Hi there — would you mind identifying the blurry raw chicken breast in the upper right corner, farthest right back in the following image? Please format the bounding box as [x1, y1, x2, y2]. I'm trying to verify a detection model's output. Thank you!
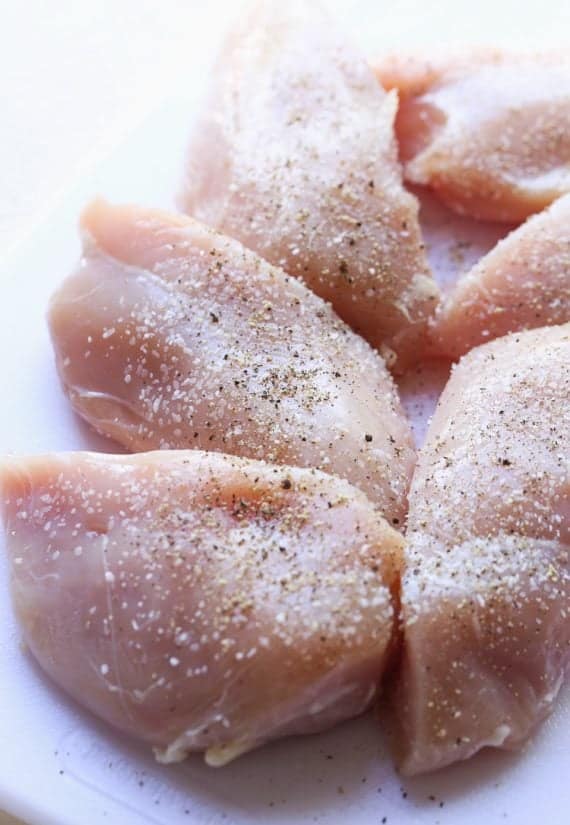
[376, 51, 570, 223]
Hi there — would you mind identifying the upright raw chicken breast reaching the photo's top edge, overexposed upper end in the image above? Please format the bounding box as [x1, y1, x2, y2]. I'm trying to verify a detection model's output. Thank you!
[183, 0, 438, 368]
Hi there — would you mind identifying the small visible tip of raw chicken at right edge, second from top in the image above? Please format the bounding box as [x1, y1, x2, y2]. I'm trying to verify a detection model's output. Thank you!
[432, 195, 570, 358]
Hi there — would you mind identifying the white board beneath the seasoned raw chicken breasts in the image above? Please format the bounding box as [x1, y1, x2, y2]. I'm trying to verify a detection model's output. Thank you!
[0, 2, 570, 825]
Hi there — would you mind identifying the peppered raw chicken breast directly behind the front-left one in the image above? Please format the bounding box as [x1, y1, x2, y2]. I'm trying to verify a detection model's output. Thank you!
[49, 201, 415, 524]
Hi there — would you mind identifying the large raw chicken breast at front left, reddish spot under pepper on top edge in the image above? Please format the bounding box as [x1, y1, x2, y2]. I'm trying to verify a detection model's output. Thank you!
[0, 450, 402, 765]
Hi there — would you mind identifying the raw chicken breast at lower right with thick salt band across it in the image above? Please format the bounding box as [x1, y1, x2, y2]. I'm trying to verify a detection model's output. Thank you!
[394, 324, 570, 774]
